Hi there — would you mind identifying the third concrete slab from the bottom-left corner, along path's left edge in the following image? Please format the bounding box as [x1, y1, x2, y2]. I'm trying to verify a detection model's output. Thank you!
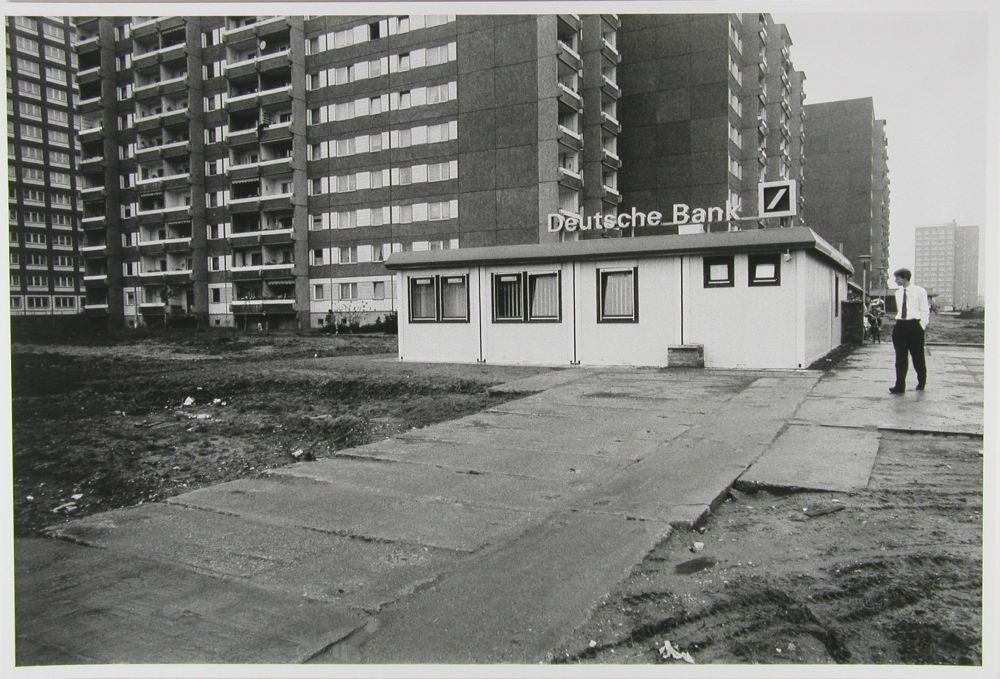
[169, 476, 530, 552]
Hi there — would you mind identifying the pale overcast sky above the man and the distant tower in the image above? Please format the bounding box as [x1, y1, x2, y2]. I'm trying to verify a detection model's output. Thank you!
[771, 3, 992, 293]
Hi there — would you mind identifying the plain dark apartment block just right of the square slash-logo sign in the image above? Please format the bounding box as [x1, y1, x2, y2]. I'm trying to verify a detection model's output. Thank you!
[804, 97, 890, 290]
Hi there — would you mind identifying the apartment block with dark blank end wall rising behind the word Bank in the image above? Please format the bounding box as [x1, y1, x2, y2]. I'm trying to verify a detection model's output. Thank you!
[619, 14, 802, 235]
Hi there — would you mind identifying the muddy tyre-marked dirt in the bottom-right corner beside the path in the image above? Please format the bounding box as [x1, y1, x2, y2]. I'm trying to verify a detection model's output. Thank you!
[556, 434, 982, 665]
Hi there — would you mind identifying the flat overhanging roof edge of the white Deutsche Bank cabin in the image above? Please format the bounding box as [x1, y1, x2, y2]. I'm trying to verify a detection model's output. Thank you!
[385, 226, 854, 274]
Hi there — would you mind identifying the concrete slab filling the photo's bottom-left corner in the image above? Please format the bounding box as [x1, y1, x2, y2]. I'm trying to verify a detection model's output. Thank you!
[15, 538, 364, 666]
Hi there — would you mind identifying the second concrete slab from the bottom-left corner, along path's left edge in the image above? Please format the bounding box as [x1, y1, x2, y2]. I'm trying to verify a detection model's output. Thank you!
[48, 503, 457, 610]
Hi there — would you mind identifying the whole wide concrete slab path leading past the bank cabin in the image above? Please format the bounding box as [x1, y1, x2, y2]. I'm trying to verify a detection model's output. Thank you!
[16, 346, 982, 665]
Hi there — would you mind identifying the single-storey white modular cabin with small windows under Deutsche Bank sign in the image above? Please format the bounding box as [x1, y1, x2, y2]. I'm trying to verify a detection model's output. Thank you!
[386, 227, 853, 369]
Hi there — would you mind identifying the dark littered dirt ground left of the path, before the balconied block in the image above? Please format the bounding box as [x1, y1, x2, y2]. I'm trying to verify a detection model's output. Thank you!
[11, 333, 541, 536]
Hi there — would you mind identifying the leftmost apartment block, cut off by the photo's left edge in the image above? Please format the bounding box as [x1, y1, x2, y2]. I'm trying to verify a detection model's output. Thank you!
[6, 16, 83, 315]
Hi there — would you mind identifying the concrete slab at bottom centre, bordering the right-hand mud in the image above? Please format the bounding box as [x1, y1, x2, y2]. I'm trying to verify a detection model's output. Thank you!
[348, 512, 670, 663]
